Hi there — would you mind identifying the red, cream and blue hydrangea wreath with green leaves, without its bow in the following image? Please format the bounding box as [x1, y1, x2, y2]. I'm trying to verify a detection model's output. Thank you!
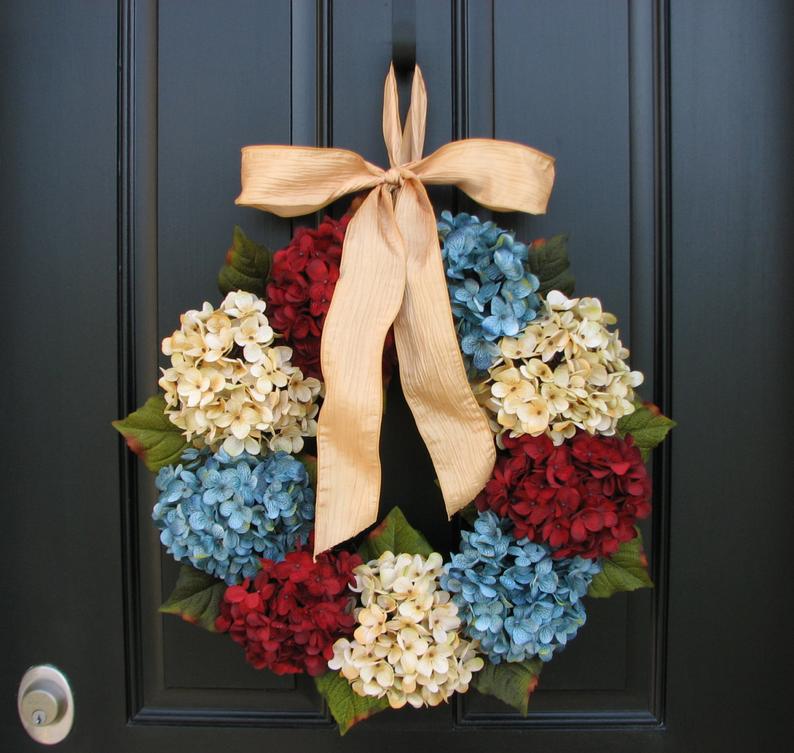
[114, 202, 674, 734]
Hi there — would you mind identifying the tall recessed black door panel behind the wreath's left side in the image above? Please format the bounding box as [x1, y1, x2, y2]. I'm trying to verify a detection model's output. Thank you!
[147, 0, 326, 723]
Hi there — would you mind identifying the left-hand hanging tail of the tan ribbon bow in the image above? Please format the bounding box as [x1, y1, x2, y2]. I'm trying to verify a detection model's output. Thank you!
[314, 186, 405, 556]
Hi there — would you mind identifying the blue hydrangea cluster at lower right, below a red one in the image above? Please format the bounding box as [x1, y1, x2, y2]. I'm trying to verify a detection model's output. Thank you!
[441, 510, 601, 664]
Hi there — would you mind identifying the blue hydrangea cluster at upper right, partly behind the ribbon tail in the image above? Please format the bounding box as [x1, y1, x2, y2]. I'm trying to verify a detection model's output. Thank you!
[438, 212, 541, 371]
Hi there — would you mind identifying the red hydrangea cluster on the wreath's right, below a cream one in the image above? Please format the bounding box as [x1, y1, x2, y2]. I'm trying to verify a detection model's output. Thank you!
[475, 431, 651, 559]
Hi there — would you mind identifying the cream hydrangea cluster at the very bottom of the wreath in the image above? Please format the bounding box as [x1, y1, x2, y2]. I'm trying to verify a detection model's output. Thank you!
[328, 552, 484, 708]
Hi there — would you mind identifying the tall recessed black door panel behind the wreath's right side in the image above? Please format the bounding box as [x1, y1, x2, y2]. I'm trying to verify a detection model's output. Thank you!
[459, 2, 666, 726]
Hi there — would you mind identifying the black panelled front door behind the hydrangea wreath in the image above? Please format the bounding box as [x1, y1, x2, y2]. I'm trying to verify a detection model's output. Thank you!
[0, 0, 794, 753]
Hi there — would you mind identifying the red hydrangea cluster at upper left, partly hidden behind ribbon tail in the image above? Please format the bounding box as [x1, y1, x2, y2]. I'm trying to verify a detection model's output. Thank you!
[265, 215, 396, 379]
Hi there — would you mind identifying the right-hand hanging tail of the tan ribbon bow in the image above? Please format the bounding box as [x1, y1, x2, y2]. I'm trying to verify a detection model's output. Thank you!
[394, 179, 496, 518]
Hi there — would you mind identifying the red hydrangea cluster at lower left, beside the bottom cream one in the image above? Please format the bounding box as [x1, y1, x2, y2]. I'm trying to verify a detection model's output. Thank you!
[215, 551, 361, 676]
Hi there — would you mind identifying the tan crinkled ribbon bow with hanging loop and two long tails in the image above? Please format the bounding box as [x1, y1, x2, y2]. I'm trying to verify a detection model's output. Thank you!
[236, 66, 554, 553]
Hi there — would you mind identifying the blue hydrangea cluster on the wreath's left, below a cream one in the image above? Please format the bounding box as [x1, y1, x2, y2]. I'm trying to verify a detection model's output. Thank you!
[152, 449, 314, 585]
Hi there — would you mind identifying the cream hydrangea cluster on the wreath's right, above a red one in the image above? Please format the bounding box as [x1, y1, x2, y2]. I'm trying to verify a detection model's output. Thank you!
[474, 290, 643, 444]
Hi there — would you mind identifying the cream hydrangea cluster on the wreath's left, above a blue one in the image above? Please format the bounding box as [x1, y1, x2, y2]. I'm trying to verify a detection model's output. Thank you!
[159, 291, 322, 457]
